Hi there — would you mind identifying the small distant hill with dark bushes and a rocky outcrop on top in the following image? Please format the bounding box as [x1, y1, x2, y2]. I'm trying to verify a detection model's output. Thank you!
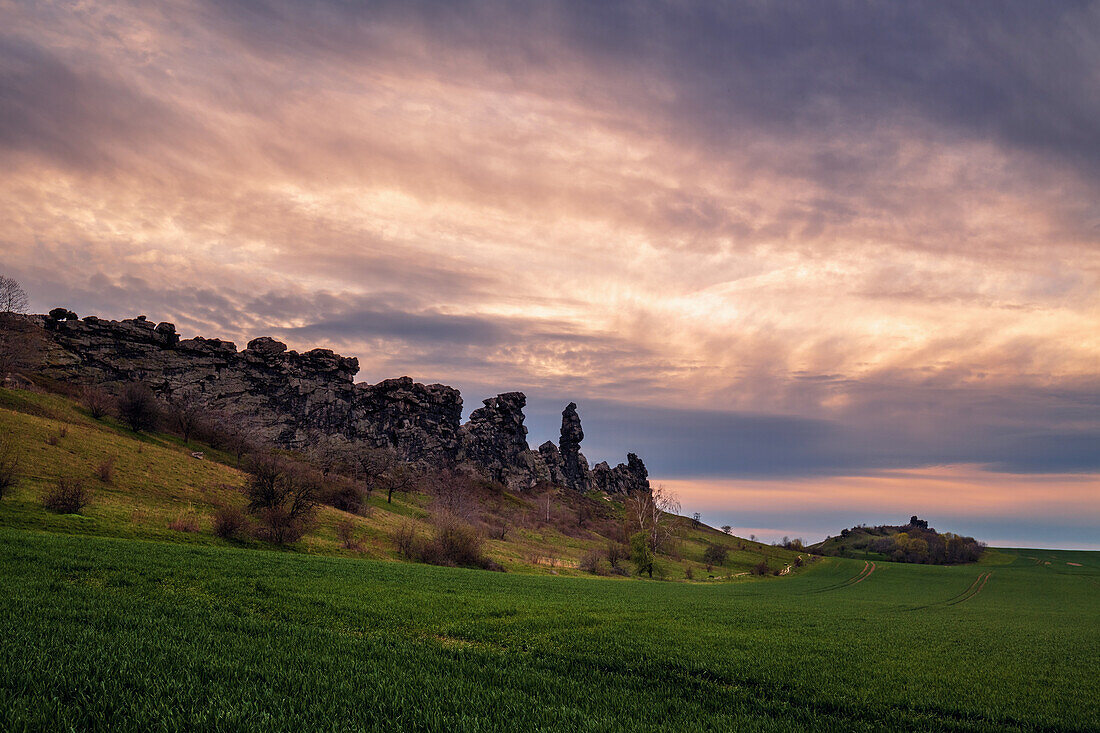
[809, 516, 986, 565]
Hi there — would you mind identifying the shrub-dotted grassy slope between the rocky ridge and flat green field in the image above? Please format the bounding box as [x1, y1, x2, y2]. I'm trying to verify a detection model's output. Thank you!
[0, 378, 809, 582]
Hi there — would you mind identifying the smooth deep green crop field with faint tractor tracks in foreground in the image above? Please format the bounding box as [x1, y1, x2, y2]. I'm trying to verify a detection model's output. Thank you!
[0, 528, 1100, 732]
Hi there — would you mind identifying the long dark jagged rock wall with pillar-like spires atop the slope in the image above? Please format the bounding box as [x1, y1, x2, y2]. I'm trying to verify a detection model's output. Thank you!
[30, 309, 649, 493]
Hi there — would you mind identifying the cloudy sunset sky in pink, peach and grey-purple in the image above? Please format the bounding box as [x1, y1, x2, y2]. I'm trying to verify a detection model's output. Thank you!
[0, 0, 1100, 549]
